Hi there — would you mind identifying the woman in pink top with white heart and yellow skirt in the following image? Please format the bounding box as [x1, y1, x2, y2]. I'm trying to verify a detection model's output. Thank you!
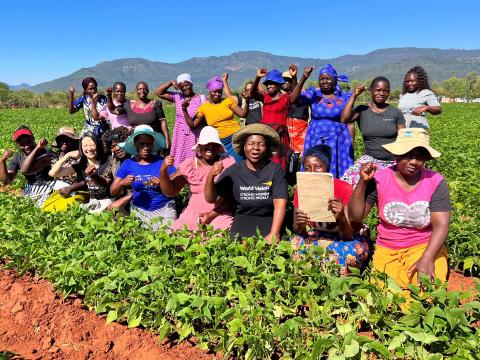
[348, 128, 451, 289]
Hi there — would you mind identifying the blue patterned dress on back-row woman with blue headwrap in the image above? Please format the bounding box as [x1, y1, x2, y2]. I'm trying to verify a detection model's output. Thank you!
[300, 87, 353, 178]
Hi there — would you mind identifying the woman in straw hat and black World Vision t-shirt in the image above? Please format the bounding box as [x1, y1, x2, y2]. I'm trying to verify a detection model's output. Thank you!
[205, 124, 288, 243]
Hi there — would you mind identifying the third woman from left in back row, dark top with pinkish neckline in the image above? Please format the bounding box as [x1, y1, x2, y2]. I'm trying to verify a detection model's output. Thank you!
[109, 81, 170, 149]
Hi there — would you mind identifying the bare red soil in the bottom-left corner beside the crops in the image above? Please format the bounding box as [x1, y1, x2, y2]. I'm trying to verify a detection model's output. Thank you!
[0, 269, 216, 360]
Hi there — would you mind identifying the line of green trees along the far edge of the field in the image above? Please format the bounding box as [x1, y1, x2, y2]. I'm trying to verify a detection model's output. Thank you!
[0, 72, 480, 109]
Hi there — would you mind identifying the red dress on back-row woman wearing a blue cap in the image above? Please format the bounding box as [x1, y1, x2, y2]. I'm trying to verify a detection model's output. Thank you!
[262, 93, 290, 171]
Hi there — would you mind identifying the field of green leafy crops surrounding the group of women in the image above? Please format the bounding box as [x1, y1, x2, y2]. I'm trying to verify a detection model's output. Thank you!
[0, 104, 480, 359]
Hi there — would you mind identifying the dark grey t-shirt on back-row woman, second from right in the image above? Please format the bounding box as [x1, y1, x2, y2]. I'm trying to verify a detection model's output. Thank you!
[353, 105, 405, 160]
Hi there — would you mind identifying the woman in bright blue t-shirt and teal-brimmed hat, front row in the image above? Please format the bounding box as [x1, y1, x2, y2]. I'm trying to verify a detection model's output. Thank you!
[110, 125, 177, 230]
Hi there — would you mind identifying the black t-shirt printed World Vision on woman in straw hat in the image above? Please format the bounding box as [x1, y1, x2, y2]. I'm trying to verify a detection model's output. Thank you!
[215, 161, 288, 237]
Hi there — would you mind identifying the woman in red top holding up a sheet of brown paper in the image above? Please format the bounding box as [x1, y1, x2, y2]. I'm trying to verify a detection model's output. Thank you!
[291, 144, 372, 274]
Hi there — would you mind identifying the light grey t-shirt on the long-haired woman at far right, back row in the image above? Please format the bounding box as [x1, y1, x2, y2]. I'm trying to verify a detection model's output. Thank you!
[398, 89, 440, 129]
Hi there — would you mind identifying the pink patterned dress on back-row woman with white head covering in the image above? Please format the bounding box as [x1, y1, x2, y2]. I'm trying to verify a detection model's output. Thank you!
[169, 92, 205, 167]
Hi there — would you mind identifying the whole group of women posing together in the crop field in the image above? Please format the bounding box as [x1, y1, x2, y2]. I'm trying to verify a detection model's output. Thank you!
[0, 65, 450, 287]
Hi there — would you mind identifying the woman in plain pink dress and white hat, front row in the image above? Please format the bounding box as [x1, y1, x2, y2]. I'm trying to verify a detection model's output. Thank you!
[160, 126, 235, 230]
